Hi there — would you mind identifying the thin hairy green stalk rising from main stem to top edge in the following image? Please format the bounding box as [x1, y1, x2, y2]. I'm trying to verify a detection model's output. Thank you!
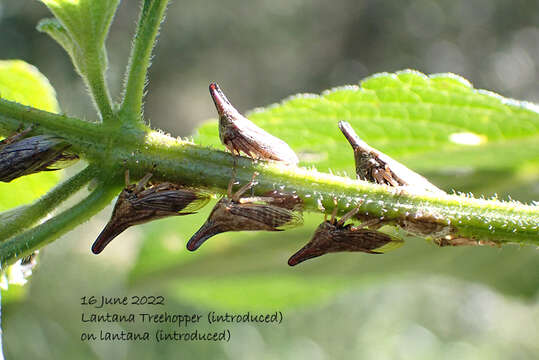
[120, 0, 168, 122]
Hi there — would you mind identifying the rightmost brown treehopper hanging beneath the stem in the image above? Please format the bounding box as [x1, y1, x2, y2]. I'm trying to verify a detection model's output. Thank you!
[288, 207, 400, 266]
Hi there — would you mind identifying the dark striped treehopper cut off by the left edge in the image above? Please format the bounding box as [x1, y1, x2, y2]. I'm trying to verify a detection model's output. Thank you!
[0, 134, 78, 182]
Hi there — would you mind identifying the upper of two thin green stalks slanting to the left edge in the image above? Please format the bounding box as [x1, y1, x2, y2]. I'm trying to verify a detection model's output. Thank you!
[0, 166, 96, 241]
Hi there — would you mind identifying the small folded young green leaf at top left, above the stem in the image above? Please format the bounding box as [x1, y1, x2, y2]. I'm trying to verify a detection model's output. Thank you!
[37, 0, 119, 83]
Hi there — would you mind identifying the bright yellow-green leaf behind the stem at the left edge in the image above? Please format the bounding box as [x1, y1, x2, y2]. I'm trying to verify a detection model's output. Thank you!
[0, 60, 60, 211]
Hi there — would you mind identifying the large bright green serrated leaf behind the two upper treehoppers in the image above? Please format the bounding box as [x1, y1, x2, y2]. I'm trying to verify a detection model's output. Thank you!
[196, 70, 539, 174]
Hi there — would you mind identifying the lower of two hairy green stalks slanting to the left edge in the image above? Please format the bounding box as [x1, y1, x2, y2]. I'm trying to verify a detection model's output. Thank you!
[0, 183, 119, 268]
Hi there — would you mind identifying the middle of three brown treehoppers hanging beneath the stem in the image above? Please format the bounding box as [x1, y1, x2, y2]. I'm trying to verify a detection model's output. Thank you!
[187, 173, 303, 251]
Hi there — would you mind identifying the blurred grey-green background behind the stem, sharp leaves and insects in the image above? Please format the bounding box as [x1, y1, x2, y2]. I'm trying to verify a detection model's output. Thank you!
[0, 0, 539, 359]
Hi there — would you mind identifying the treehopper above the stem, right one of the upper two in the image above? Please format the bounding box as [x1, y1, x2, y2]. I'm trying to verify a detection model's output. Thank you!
[339, 121, 443, 192]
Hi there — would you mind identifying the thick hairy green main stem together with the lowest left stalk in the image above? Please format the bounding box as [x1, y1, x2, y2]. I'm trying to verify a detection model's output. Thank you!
[0, 101, 539, 261]
